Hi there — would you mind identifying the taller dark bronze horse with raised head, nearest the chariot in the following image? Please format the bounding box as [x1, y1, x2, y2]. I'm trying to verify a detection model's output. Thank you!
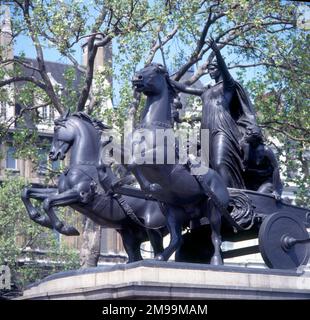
[108, 63, 229, 265]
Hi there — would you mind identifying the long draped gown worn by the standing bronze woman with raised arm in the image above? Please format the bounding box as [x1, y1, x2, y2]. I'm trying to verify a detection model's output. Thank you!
[201, 78, 252, 189]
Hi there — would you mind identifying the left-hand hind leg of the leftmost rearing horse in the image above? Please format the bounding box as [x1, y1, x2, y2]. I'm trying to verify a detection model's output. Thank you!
[117, 227, 143, 263]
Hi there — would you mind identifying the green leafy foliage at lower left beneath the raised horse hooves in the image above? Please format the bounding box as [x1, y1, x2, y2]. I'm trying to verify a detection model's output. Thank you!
[0, 177, 79, 289]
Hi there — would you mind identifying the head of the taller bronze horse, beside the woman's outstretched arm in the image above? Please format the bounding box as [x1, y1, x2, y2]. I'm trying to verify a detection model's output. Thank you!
[132, 63, 169, 96]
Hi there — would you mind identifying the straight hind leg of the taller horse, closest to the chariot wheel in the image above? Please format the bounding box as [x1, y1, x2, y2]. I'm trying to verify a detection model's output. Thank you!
[207, 204, 223, 265]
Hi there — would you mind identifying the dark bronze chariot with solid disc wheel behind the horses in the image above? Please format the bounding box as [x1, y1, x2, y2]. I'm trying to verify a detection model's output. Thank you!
[176, 189, 310, 269]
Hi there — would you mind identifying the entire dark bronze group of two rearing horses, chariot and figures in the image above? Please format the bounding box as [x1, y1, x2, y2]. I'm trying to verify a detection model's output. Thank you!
[22, 40, 310, 269]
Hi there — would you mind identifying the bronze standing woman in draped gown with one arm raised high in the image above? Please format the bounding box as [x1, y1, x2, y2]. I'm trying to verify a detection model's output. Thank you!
[172, 39, 256, 189]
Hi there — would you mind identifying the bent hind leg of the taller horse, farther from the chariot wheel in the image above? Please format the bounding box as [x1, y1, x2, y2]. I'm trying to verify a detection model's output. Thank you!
[155, 206, 184, 261]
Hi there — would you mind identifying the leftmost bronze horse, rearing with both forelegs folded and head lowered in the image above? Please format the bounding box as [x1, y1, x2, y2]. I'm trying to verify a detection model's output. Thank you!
[22, 112, 166, 263]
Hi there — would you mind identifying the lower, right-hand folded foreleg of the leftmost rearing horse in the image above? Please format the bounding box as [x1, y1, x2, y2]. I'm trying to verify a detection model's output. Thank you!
[43, 190, 80, 236]
